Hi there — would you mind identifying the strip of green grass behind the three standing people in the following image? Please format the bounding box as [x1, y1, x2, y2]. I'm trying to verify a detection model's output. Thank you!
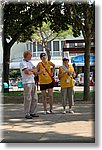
[3, 91, 95, 104]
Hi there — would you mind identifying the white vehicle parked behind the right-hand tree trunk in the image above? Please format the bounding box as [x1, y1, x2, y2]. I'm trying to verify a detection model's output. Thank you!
[75, 72, 94, 86]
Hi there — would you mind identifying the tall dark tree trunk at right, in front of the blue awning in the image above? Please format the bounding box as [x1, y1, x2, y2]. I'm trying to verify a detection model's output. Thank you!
[83, 3, 91, 101]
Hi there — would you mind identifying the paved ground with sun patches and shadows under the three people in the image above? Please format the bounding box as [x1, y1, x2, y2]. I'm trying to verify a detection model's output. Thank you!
[0, 103, 95, 143]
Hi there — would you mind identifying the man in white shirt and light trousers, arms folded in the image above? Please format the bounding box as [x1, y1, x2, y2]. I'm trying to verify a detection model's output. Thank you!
[20, 51, 39, 119]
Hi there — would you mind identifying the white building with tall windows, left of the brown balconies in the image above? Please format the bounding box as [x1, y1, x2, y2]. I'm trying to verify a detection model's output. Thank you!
[10, 37, 82, 69]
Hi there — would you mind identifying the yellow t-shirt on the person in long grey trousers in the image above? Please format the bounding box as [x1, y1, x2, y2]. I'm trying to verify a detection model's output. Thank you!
[59, 64, 74, 88]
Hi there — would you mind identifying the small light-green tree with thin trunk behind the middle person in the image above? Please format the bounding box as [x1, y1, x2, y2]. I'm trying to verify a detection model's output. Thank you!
[31, 22, 72, 60]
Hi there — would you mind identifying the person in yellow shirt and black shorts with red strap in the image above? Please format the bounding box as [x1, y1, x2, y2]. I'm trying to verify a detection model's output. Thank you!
[37, 53, 55, 114]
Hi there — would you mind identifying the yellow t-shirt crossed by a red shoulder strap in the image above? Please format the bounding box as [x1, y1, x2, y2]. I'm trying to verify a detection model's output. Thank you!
[39, 61, 52, 84]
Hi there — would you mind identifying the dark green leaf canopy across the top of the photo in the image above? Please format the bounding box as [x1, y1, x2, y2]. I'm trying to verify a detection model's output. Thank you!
[3, 1, 95, 41]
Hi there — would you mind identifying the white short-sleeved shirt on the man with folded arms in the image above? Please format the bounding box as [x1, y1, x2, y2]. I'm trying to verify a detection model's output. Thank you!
[20, 59, 35, 84]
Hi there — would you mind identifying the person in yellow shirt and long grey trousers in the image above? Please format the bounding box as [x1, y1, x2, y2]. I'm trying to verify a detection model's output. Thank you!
[58, 57, 75, 114]
